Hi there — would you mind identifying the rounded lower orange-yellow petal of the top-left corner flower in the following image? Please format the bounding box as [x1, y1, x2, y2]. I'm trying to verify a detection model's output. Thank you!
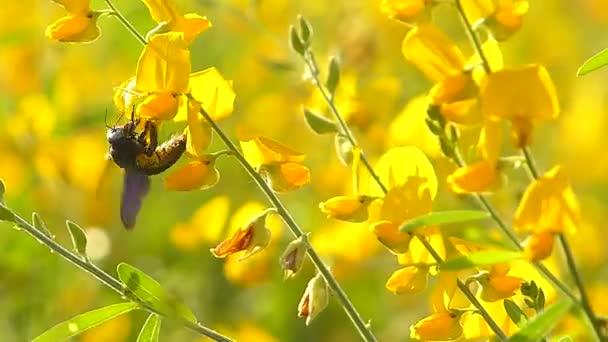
[45, 12, 100, 43]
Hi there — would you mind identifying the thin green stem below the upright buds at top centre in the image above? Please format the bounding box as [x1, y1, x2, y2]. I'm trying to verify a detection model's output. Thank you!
[303, 49, 388, 194]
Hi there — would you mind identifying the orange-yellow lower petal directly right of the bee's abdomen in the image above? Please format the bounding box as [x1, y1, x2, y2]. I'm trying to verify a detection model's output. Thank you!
[164, 156, 220, 191]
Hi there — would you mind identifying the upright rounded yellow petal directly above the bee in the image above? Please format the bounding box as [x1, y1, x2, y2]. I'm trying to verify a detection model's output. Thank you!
[135, 32, 191, 94]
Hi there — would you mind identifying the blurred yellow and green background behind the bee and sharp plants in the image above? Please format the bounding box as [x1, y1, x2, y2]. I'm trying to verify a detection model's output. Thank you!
[0, 0, 608, 341]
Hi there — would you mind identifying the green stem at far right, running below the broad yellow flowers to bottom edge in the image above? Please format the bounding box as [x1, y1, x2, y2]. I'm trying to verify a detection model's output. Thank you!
[522, 146, 606, 341]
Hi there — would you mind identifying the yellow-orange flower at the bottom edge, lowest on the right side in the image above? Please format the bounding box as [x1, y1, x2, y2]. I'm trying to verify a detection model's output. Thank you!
[410, 309, 463, 341]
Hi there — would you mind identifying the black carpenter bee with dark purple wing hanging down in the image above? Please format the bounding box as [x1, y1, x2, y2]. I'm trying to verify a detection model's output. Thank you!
[107, 115, 186, 229]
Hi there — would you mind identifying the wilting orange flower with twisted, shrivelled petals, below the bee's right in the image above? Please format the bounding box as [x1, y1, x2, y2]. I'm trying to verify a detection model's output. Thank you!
[211, 209, 275, 260]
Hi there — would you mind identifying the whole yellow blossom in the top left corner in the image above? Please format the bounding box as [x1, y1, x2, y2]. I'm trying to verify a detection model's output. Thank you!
[44, 0, 101, 43]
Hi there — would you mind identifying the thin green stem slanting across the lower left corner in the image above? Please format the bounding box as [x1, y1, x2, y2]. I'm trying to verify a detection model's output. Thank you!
[6, 208, 232, 342]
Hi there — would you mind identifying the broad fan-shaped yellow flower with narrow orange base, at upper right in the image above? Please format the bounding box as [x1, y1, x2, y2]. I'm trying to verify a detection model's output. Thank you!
[481, 65, 559, 147]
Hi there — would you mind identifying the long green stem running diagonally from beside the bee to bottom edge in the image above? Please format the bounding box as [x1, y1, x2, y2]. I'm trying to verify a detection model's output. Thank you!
[200, 107, 376, 341]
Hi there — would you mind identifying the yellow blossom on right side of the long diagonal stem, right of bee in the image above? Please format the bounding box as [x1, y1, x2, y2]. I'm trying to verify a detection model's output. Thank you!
[241, 137, 310, 192]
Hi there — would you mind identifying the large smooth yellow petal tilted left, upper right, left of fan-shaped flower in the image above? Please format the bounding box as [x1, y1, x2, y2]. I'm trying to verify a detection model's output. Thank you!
[401, 24, 466, 83]
